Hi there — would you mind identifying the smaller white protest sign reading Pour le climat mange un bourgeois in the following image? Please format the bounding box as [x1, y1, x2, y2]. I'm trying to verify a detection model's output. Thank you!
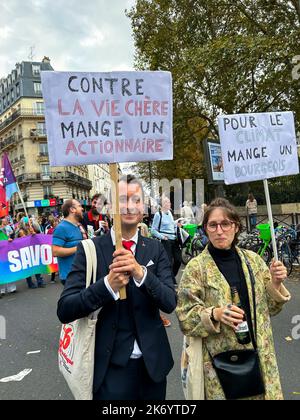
[218, 112, 299, 185]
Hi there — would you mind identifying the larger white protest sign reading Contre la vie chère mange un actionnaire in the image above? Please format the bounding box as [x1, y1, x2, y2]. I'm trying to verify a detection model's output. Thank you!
[41, 71, 173, 166]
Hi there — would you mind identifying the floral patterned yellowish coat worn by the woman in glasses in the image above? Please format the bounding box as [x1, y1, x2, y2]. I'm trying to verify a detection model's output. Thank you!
[176, 248, 291, 400]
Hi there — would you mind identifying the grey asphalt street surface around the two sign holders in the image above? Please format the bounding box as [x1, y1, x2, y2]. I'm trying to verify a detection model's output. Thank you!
[0, 270, 300, 400]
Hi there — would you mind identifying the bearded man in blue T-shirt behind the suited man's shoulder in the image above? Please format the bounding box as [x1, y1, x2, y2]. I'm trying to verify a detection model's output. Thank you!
[52, 199, 86, 285]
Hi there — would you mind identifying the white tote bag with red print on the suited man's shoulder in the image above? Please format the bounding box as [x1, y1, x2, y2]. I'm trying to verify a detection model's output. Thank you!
[58, 239, 100, 400]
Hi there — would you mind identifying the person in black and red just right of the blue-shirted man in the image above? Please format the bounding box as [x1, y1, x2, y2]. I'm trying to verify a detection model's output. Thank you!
[82, 194, 110, 236]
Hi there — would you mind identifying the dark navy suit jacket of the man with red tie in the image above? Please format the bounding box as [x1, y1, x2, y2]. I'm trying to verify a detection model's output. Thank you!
[57, 234, 176, 392]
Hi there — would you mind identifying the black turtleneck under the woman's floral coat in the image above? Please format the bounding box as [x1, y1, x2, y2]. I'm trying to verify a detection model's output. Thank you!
[208, 243, 252, 340]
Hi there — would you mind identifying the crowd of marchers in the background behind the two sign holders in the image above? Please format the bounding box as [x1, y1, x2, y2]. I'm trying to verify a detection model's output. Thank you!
[0, 193, 206, 298]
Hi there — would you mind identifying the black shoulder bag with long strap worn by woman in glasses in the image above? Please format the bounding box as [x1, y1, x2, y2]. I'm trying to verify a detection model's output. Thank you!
[210, 254, 265, 400]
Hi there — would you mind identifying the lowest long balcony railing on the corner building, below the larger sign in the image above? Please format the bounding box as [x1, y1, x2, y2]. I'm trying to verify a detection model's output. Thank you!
[17, 171, 92, 189]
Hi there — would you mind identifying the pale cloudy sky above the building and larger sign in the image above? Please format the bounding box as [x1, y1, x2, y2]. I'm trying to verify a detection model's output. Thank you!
[0, 0, 135, 78]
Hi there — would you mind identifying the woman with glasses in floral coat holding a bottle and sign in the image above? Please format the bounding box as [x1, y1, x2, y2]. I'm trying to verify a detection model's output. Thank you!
[177, 199, 291, 400]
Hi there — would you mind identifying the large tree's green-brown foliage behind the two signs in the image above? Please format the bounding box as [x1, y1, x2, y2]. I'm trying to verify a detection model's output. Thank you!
[127, 0, 300, 190]
